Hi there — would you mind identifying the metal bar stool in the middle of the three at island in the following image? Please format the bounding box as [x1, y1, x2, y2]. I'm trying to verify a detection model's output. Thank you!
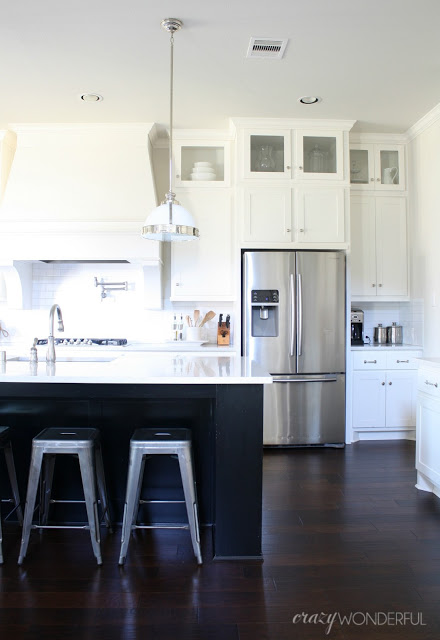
[18, 427, 112, 564]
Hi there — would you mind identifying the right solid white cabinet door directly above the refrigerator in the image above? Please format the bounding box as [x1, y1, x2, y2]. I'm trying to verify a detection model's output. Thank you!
[296, 187, 345, 243]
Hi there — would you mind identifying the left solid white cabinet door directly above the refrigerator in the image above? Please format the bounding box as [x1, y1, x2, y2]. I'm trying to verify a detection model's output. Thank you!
[243, 187, 292, 243]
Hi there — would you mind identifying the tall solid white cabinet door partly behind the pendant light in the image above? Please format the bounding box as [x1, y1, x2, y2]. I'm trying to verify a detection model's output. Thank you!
[171, 189, 234, 301]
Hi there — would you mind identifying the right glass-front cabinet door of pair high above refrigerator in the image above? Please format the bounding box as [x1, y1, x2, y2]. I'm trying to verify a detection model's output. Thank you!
[295, 131, 344, 180]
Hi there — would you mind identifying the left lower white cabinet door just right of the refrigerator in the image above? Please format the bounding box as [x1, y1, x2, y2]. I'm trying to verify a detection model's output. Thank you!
[353, 371, 385, 429]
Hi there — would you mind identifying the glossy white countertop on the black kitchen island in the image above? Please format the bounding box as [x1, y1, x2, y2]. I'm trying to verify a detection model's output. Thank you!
[0, 350, 272, 384]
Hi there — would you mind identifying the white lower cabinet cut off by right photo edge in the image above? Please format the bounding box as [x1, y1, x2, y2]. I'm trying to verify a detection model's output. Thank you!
[416, 363, 440, 496]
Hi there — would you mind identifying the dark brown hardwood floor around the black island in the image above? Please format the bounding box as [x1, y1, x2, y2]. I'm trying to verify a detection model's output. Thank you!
[0, 442, 440, 640]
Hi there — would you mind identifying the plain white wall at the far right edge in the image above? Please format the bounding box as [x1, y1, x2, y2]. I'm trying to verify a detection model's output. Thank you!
[408, 107, 440, 357]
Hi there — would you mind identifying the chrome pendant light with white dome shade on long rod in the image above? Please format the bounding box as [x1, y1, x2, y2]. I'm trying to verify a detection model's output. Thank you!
[142, 18, 199, 242]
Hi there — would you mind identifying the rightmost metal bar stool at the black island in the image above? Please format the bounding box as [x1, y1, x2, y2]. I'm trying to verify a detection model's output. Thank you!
[119, 429, 202, 565]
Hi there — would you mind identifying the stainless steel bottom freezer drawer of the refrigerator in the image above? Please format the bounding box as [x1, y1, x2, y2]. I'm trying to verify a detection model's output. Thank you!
[263, 374, 345, 445]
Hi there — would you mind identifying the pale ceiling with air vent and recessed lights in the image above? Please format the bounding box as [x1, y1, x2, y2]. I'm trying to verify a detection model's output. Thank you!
[0, 0, 440, 132]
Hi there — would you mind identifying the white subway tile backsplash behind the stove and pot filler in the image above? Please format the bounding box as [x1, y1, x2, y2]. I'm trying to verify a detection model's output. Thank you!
[0, 262, 234, 343]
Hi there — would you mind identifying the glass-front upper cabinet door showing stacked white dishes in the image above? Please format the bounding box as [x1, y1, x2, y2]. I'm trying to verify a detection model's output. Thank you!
[173, 140, 230, 187]
